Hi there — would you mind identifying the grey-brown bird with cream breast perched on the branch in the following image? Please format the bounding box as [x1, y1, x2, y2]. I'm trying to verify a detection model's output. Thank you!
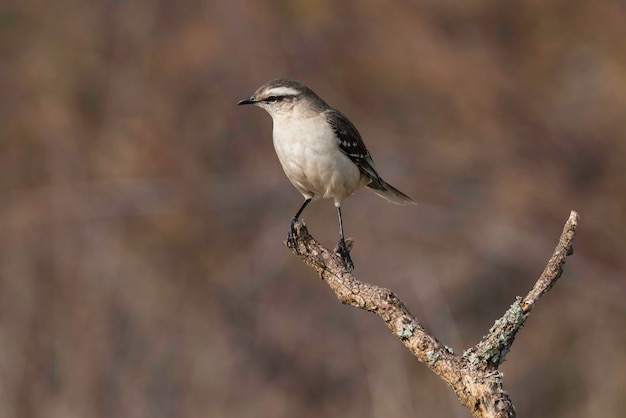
[237, 78, 416, 271]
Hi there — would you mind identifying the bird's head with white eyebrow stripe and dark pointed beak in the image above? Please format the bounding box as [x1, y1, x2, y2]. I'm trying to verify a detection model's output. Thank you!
[237, 78, 328, 117]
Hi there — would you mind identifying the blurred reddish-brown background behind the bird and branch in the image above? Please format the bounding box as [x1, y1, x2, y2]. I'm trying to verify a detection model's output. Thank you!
[0, 0, 626, 418]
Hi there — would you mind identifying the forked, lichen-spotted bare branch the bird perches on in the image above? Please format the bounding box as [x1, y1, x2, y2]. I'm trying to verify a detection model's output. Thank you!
[285, 211, 579, 418]
